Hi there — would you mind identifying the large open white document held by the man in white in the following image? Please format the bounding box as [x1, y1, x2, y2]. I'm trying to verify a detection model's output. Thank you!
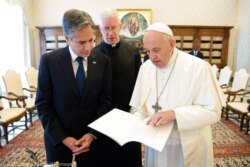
[88, 109, 173, 152]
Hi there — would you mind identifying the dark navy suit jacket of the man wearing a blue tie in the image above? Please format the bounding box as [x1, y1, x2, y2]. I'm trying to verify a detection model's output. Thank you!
[36, 47, 112, 166]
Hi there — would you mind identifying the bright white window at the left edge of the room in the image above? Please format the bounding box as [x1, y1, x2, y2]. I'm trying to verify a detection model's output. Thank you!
[0, 0, 29, 92]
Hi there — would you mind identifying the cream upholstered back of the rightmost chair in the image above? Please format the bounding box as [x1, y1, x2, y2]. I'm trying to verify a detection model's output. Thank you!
[231, 69, 249, 91]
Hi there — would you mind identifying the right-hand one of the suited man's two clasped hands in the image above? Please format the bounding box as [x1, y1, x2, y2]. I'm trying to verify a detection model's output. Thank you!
[72, 133, 95, 155]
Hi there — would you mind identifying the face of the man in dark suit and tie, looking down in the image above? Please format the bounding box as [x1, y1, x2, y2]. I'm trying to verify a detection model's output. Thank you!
[66, 26, 95, 57]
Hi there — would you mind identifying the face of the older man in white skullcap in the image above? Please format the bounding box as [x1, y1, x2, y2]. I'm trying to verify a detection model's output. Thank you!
[143, 31, 175, 68]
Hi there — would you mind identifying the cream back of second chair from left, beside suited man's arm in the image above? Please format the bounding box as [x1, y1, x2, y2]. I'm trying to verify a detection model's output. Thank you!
[25, 67, 38, 88]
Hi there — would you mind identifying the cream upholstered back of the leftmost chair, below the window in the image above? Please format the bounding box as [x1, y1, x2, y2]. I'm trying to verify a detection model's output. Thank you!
[3, 70, 24, 97]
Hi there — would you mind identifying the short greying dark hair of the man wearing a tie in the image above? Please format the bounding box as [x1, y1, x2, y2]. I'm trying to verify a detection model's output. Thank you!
[62, 9, 95, 39]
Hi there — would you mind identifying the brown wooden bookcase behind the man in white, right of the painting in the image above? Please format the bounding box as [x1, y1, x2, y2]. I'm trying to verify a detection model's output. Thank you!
[170, 25, 233, 68]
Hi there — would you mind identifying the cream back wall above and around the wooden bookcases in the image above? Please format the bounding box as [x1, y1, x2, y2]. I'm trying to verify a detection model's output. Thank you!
[29, 0, 250, 72]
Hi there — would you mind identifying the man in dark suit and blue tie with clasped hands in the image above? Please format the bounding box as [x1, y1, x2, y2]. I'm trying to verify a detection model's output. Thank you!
[36, 9, 112, 167]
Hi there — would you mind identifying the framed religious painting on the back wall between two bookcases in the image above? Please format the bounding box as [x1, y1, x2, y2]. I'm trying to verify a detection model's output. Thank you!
[117, 9, 151, 51]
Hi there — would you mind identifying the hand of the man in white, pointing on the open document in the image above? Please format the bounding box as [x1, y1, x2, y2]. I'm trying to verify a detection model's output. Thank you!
[147, 110, 175, 127]
